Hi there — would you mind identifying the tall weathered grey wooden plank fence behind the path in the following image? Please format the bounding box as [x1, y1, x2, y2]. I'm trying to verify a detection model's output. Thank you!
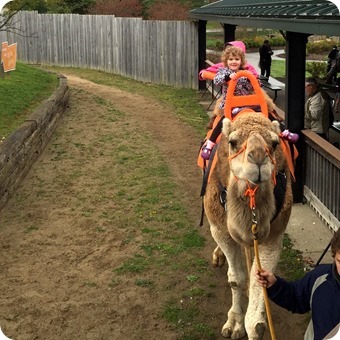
[0, 11, 198, 89]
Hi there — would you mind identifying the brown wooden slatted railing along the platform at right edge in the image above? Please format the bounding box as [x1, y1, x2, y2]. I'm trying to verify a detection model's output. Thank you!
[302, 130, 340, 230]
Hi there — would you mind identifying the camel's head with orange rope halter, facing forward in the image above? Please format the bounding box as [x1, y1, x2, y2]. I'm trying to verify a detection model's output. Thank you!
[222, 112, 280, 185]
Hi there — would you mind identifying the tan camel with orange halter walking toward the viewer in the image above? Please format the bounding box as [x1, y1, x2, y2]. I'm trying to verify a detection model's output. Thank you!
[203, 112, 293, 340]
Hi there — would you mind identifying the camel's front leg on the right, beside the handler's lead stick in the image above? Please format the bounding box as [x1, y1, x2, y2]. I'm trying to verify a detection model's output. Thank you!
[245, 241, 281, 340]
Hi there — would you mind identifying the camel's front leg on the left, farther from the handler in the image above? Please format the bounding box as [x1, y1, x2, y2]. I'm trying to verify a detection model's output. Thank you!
[211, 226, 247, 339]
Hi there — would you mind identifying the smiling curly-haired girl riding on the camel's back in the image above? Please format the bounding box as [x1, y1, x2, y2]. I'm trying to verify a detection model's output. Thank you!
[201, 46, 260, 160]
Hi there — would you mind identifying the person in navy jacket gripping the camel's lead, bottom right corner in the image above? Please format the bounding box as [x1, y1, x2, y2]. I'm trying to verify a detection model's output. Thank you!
[255, 228, 340, 340]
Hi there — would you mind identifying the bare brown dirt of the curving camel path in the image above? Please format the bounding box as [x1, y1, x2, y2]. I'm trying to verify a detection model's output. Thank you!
[0, 74, 306, 340]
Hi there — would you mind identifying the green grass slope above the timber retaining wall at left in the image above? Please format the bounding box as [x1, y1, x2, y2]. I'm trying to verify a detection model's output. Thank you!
[0, 62, 58, 137]
